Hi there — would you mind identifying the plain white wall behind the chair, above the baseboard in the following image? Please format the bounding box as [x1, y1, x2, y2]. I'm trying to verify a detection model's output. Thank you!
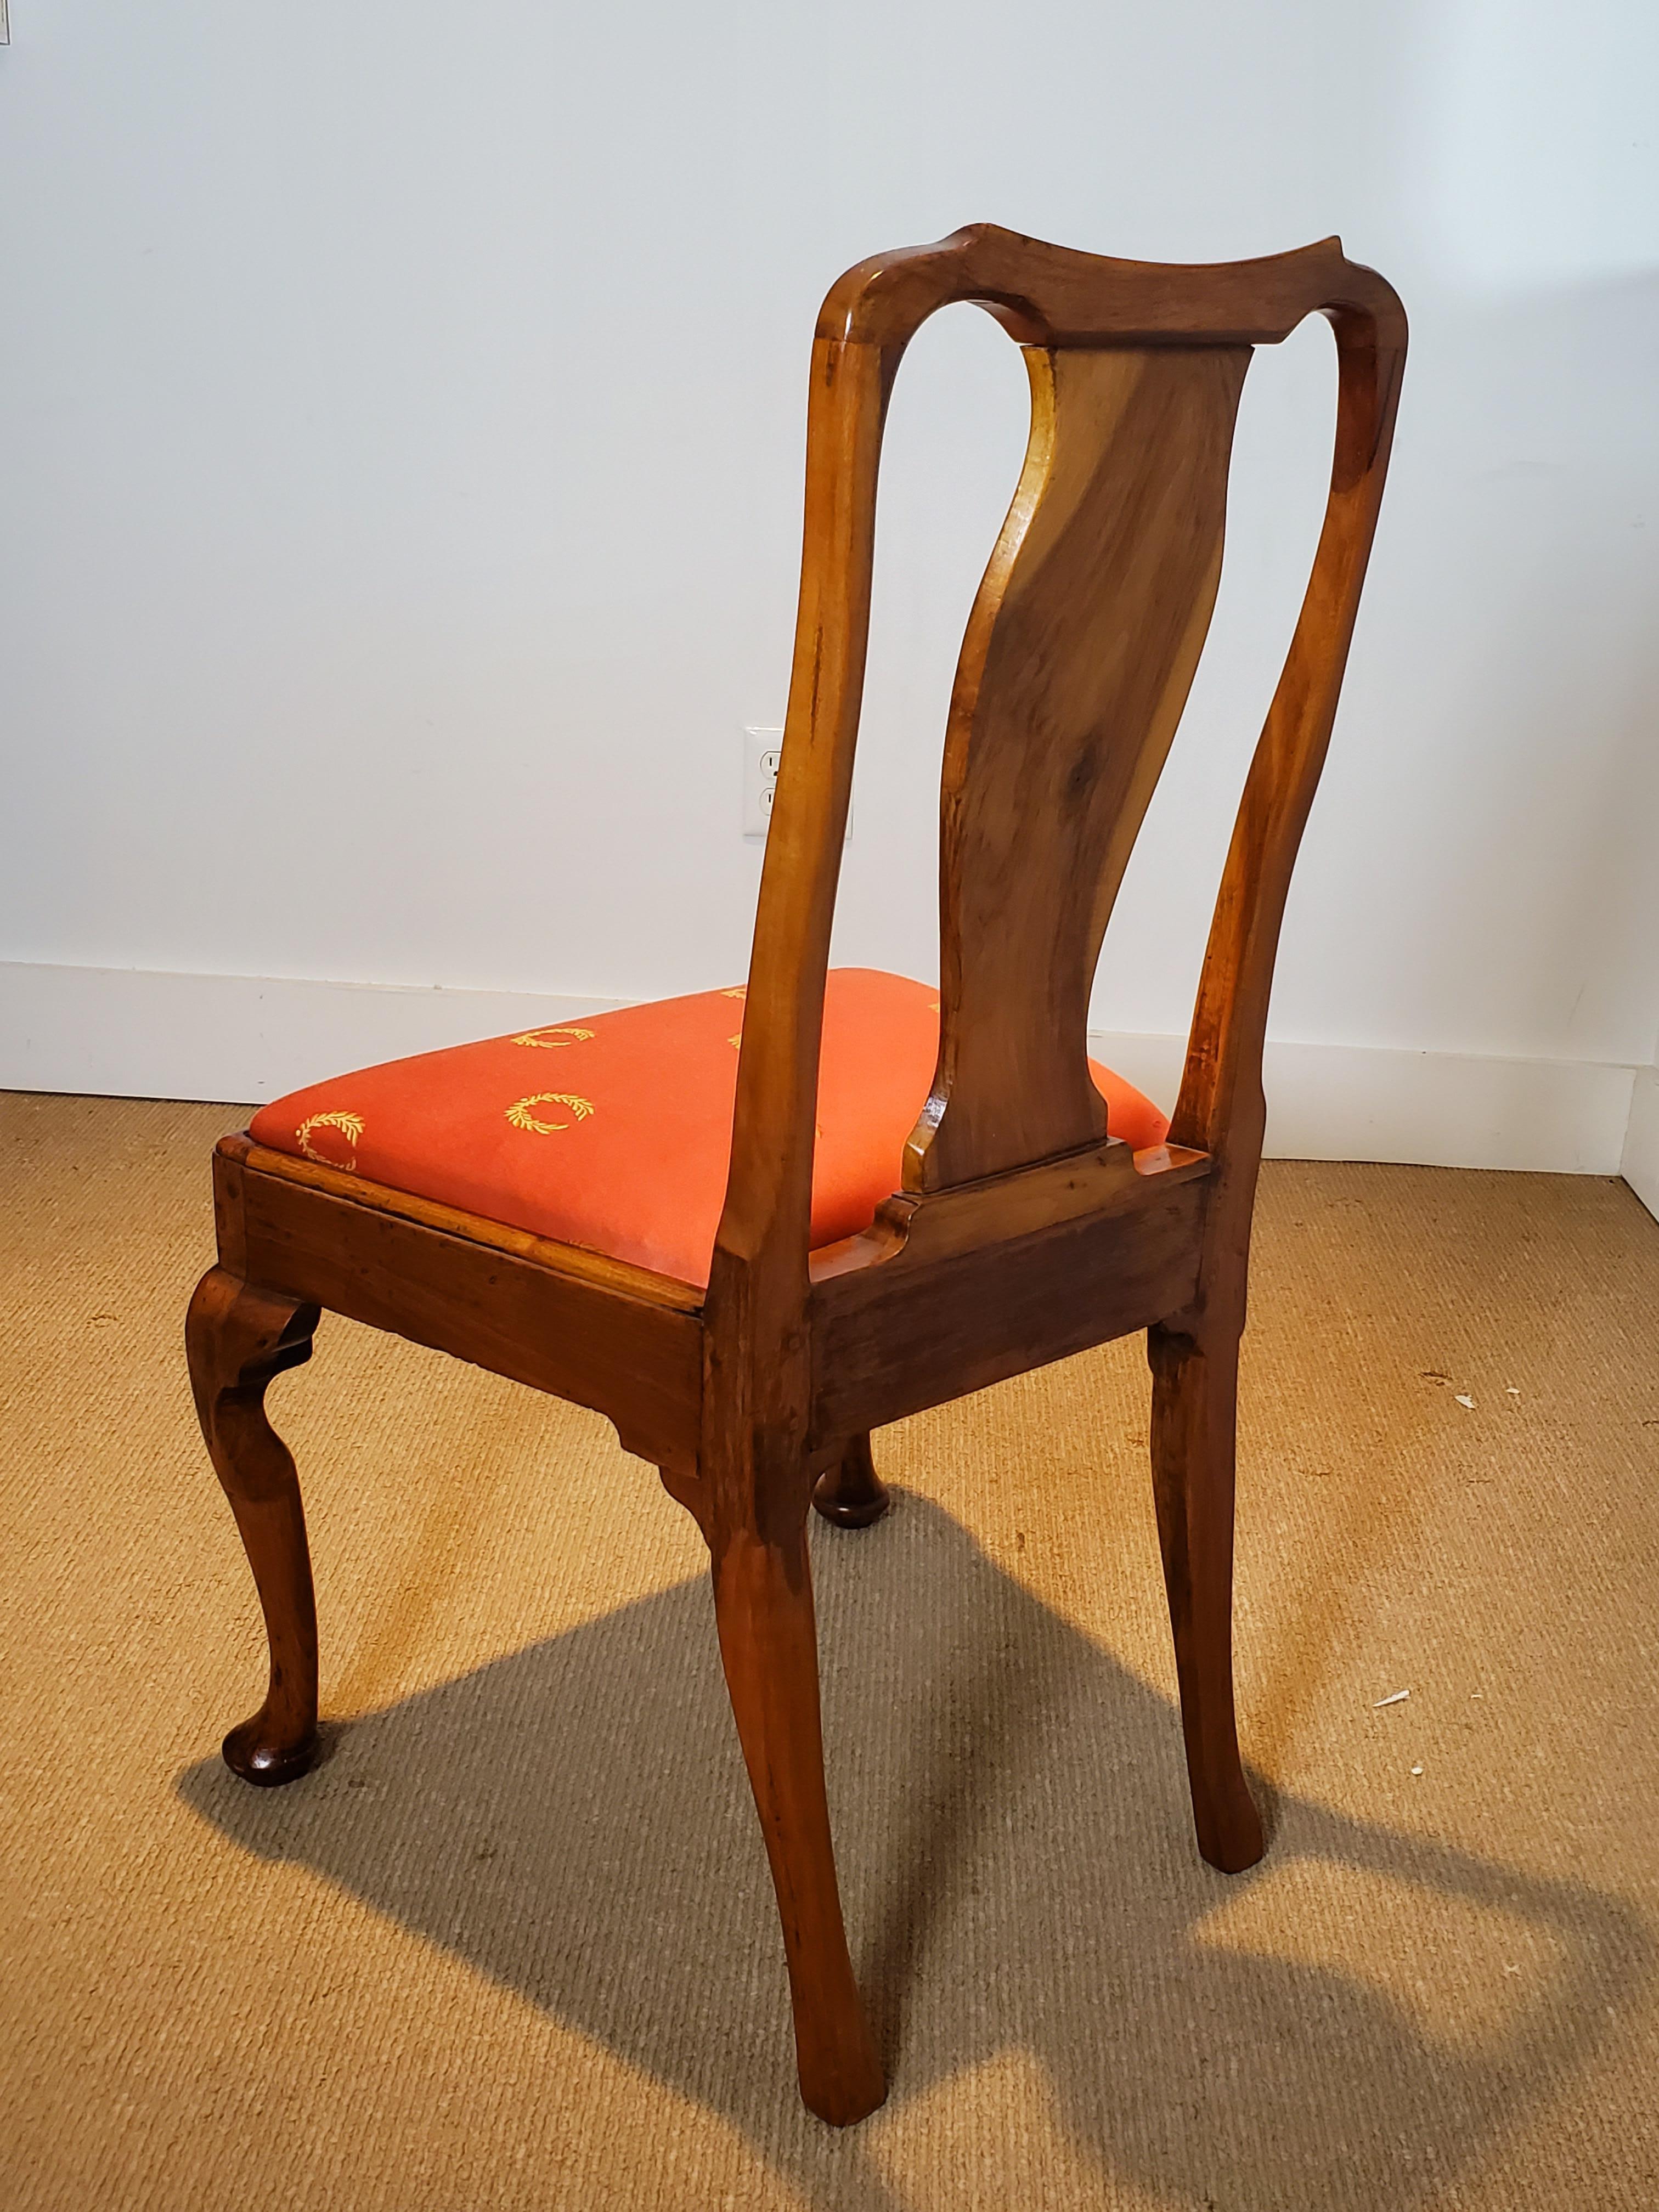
[0, 0, 1659, 1168]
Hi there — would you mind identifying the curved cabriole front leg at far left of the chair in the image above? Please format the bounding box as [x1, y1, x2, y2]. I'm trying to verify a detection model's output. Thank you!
[184, 1267, 319, 1785]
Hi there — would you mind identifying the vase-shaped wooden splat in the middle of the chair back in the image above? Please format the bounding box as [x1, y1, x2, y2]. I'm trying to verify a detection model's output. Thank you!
[924, 345, 1250, 1190]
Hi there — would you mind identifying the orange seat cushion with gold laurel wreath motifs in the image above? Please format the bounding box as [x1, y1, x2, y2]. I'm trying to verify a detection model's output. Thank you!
[252, 969, 1168, 1285]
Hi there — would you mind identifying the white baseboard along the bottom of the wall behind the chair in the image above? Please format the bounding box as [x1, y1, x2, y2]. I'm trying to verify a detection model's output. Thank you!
[0, 962, 1659, 1186]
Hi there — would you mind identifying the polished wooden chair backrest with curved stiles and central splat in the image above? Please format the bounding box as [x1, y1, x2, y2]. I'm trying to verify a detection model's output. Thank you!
[708, 225, 1404, 1451]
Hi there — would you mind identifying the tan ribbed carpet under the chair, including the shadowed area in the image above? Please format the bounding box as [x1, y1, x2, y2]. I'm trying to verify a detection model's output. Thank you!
[0, 1097, 1659, 2212]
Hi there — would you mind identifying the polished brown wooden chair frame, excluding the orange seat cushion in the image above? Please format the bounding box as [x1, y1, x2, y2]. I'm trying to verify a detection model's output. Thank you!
[188, 225, 1404, 2124]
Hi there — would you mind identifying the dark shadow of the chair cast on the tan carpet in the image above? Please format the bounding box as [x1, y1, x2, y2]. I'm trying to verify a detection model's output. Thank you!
[179, 1493, 1650, 2212]
